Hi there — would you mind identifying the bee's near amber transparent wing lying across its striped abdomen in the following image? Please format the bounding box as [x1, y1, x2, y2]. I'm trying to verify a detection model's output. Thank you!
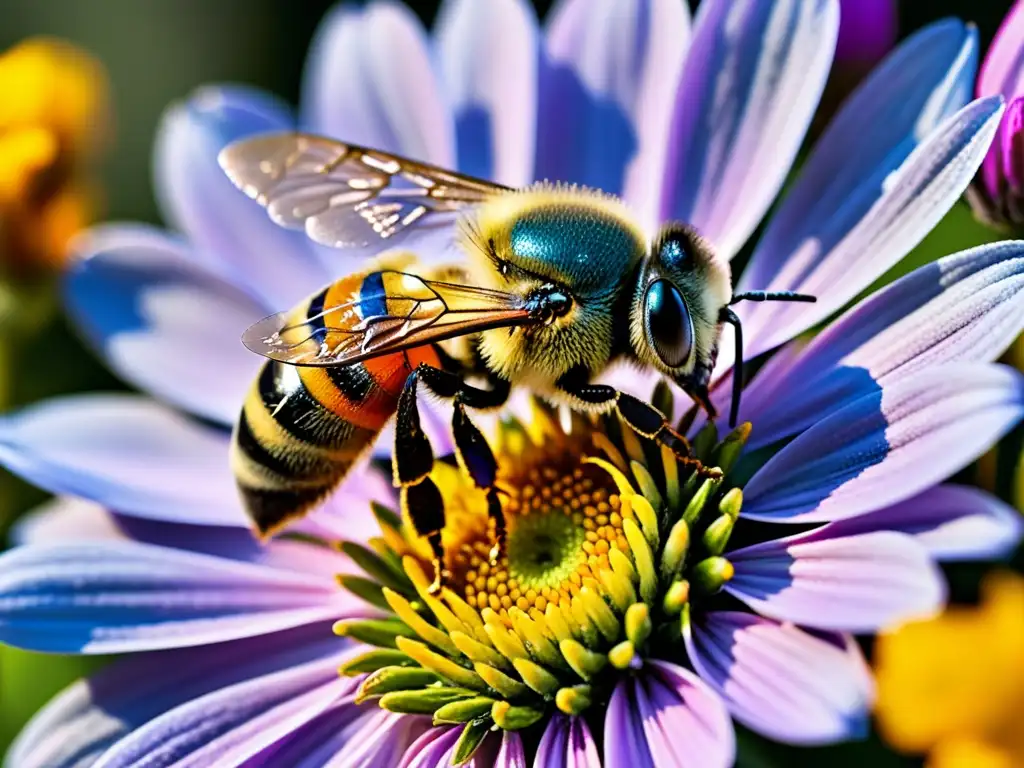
[242, 271, 538, 367]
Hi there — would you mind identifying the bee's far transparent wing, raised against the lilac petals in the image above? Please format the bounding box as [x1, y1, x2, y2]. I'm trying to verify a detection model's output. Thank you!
[218, 133, 508, 248]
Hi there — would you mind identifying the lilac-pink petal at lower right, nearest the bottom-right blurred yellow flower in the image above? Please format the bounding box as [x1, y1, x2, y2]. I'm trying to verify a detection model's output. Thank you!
[684, 611, 873, 744]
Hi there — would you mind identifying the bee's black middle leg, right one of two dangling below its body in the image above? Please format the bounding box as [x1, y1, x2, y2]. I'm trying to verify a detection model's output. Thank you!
[421, 367, 511, 565]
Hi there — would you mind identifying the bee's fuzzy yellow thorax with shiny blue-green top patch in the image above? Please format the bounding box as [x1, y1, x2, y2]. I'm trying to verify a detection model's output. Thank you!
[461, 184, 645, 393]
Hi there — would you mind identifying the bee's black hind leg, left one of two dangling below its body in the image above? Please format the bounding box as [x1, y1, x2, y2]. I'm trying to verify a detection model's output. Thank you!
[391, 371, 451, 594]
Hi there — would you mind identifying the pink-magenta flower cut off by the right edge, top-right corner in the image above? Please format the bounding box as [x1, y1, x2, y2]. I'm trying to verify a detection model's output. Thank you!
[968, 1, 1024, 230]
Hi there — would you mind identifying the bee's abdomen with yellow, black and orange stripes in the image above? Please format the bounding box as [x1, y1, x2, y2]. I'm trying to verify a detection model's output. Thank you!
[231, 272, 437, 535]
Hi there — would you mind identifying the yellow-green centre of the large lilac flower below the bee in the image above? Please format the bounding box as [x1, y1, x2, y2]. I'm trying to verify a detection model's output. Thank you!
[336, 397, 749, 760]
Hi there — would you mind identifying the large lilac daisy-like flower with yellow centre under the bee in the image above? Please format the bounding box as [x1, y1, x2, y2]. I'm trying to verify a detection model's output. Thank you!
[0, 0, 1024, 768]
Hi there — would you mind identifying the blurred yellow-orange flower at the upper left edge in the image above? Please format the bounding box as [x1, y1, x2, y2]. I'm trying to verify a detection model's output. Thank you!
[0, 38, 110, 276]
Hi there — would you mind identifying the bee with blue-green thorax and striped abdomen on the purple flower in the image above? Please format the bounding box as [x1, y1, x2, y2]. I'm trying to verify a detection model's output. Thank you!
[219, 133, 814, 589]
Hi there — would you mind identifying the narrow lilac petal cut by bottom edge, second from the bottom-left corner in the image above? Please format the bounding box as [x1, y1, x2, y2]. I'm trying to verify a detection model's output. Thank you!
[96, 655, 356, 768]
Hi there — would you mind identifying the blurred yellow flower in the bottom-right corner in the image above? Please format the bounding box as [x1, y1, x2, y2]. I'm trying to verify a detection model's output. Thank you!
[876, 572, 1024, 768]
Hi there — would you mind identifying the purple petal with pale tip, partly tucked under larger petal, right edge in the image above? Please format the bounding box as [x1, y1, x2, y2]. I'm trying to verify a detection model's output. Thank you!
[822, 485, 1024, 560]
